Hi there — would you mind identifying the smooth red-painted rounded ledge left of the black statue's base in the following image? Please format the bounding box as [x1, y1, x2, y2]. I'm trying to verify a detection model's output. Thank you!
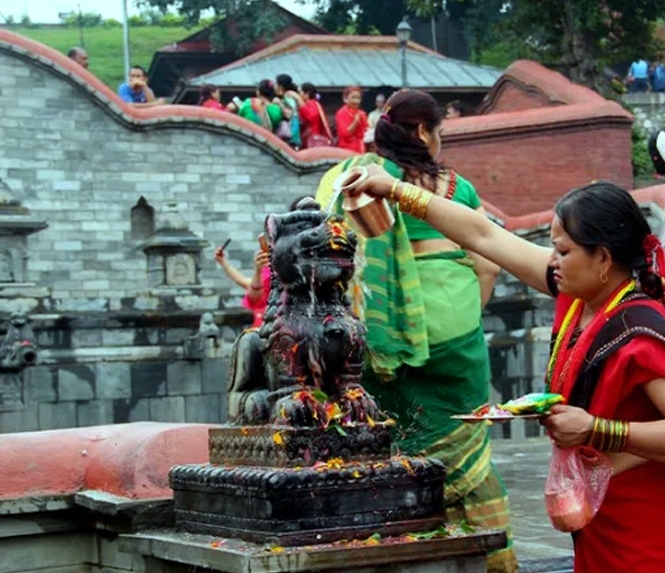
[0, 422, 212, 499]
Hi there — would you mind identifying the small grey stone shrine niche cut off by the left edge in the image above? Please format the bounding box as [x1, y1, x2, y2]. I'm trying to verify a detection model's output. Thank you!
[0, 179, 48, 289]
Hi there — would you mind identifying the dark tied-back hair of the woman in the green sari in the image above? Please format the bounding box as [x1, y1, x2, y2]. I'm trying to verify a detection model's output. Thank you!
[374, 90, 443, 186]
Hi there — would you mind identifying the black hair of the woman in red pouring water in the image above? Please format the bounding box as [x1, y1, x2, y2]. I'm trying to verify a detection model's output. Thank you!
[554, 181, 665, 300]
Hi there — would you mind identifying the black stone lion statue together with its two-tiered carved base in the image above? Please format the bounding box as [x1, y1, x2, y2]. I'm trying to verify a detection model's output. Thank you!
[169, 200, 446, 545]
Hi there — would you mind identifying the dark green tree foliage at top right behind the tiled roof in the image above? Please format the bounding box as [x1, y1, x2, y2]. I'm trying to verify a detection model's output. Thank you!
[406, 0, 665, 88]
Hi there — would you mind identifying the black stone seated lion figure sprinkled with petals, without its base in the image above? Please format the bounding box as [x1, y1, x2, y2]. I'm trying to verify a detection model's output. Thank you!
[228, 199, 379, 428]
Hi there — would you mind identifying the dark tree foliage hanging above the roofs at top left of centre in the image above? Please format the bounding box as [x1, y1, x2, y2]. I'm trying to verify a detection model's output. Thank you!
[140, 0, 285, 55]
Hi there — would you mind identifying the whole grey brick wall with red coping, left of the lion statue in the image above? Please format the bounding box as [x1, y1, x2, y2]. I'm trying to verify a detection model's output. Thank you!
[0, 30, 348, 432]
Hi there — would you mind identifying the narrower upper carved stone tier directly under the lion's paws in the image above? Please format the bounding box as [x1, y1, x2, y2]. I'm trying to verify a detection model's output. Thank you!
[208, 423, 391, 467]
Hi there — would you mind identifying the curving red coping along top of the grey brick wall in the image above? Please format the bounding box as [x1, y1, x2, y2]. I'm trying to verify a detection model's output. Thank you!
[0, 29, 353, 168]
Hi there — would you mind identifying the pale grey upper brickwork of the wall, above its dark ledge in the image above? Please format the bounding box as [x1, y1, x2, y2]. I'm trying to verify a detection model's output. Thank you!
[0, 40, 344, 311]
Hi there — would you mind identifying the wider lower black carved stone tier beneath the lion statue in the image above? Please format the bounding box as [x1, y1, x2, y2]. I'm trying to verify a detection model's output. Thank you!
[169, 457, 446, 545]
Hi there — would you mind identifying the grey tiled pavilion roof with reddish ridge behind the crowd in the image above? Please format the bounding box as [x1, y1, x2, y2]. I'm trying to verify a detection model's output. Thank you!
[189, 35, 502, 90]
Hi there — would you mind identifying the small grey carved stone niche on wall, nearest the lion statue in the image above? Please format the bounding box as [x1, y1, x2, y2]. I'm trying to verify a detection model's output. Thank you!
[141, 203, 209, 289]
